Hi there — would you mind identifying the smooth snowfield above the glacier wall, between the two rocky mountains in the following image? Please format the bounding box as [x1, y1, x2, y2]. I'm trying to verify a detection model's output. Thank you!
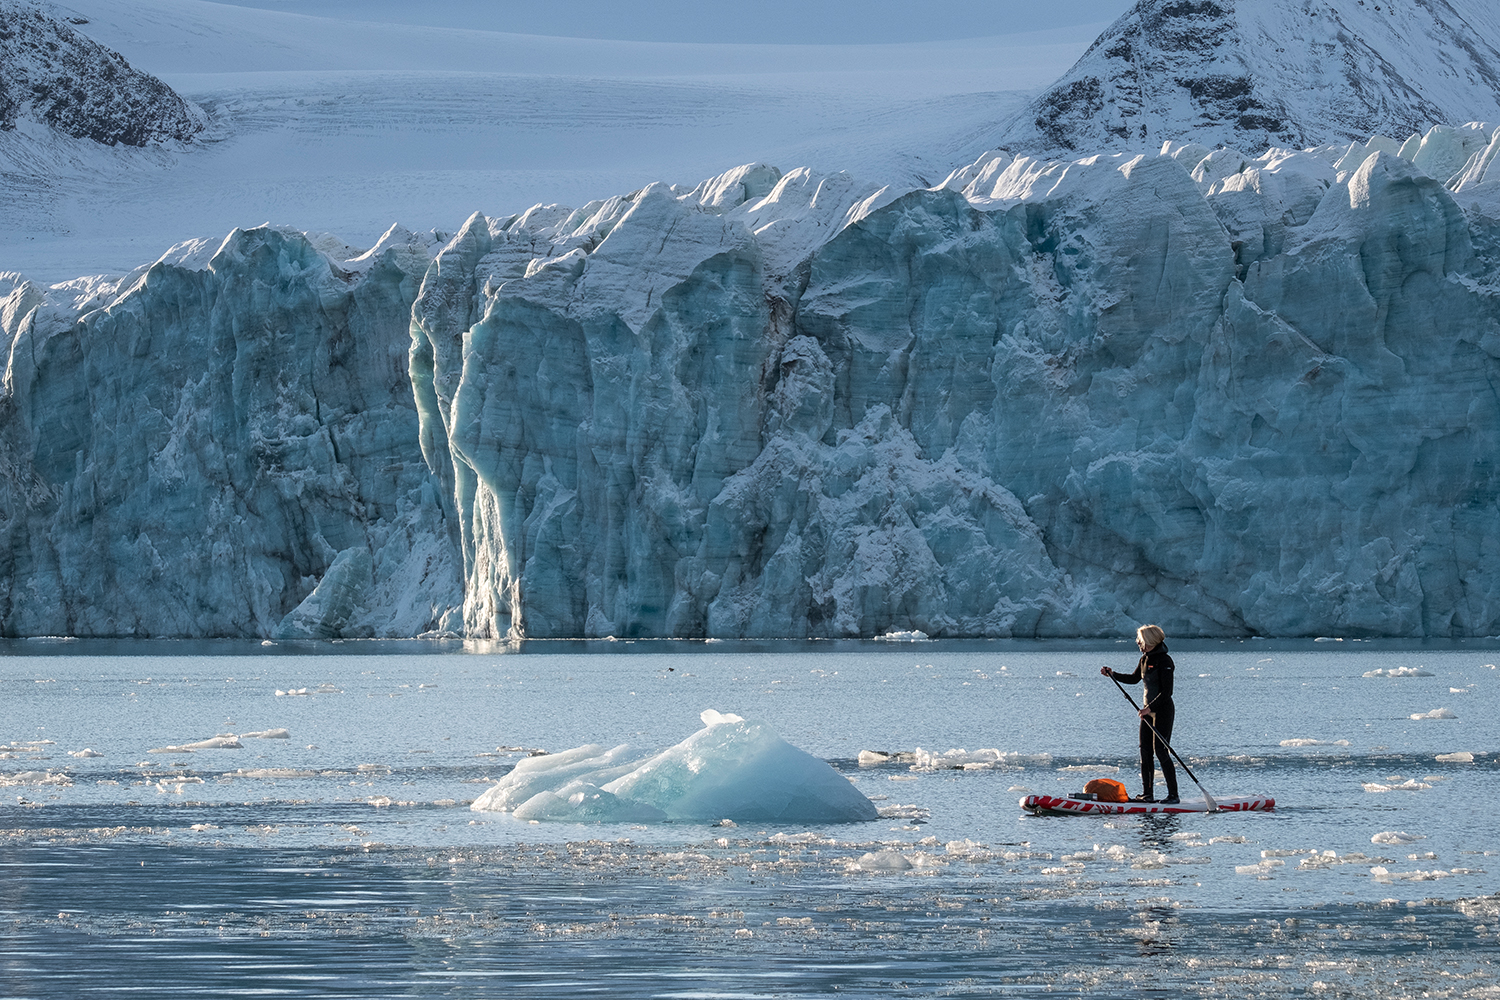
[0, 0, 1098, 282]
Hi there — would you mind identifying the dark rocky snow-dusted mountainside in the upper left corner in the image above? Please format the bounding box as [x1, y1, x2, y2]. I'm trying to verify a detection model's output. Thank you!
[0, 0, 207, 145]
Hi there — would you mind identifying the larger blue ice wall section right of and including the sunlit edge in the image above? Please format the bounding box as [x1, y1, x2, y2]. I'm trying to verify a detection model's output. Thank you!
[413, 140, 1500, 636]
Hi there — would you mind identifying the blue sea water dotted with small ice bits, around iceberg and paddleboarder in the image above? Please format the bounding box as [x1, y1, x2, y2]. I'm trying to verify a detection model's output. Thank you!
[0, 640, 1500, 999]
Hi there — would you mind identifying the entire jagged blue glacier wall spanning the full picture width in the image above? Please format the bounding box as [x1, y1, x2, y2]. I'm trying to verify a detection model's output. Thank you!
[0, 126, 1500, 637]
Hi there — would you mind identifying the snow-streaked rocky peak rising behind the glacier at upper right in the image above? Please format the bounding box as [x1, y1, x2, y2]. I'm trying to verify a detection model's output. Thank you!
[992, 0, 1500, 154]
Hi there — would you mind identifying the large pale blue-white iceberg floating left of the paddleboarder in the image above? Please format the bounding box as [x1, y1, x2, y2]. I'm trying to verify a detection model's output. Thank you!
[471, 709, 878, 823]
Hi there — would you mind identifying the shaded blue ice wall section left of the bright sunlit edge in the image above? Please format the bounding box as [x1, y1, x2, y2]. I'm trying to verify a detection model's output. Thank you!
[0, 228, 462, 639]
